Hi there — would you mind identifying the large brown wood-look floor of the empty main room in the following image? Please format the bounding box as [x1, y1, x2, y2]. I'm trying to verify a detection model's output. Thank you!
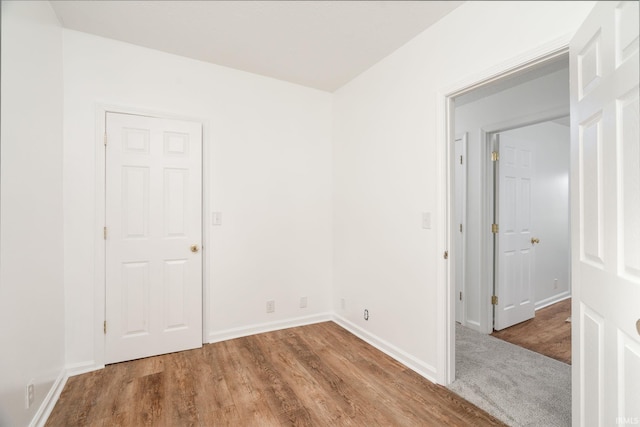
[46, 322, 504, 427]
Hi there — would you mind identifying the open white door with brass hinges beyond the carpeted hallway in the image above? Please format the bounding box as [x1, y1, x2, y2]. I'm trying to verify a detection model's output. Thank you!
[494, 132, 535, 330]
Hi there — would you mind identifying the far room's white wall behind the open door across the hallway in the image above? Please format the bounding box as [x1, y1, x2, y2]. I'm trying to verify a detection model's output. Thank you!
[500, 122, 571, 309]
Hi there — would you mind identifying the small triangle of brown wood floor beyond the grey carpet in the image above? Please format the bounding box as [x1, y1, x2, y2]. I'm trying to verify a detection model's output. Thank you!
[491, 299, 571, 364]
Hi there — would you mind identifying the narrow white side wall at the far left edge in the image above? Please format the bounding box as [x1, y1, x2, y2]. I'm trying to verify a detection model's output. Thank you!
[0, 1, 65, 426]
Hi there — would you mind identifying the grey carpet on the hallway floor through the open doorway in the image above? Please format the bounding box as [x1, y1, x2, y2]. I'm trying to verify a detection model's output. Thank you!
[449, 325, 571, 427]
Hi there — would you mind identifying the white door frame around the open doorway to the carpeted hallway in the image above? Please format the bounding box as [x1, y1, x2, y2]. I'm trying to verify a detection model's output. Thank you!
[437, 34, 572, 386]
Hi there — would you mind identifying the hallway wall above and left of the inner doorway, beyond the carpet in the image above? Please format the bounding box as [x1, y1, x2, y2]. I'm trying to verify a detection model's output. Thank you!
[455, 68, 569, 333]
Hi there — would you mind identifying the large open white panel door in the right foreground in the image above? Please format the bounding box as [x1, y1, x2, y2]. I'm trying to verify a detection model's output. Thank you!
[570, 1, 640, 426]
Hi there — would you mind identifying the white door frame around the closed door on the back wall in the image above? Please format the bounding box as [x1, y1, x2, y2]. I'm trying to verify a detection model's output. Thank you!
[93, 104, 212, 369]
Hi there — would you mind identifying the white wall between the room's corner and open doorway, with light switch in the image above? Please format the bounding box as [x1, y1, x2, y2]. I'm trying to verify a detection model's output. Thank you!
[333, 2, 593, 380]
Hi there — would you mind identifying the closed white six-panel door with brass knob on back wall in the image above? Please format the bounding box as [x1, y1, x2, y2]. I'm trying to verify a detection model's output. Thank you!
[105, 113, 202, 363]
